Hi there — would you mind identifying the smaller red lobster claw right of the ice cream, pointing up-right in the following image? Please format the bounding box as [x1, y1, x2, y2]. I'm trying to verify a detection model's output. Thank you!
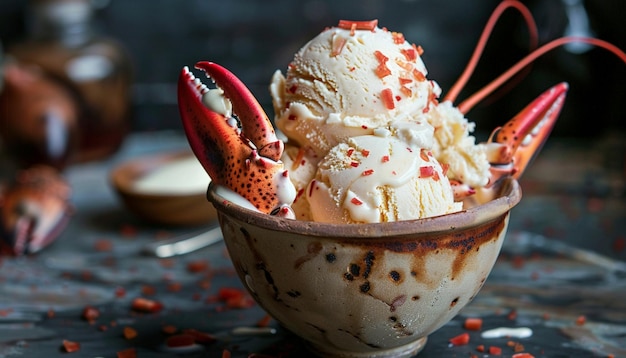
[487, 82, 569, 186]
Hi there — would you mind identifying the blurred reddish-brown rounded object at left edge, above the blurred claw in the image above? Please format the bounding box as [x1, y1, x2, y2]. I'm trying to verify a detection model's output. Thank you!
[0, 61, 79, 174]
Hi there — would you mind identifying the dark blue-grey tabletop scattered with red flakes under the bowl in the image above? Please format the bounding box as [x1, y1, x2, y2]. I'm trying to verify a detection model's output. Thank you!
[0, 131, 626, 358]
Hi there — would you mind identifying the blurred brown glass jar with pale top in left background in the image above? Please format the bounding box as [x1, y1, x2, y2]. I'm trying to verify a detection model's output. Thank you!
[7, 0, 132, 162]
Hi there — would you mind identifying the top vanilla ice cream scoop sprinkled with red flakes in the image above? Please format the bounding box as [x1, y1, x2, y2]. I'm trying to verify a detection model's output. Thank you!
[270, 21, 440, 157]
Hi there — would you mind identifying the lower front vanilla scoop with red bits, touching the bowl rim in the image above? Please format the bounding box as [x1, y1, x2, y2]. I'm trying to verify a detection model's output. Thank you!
[305, 123, 462, 223]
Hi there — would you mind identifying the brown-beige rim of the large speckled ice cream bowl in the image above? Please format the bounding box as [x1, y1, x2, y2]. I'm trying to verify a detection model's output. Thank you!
[207, 177, 522, 239]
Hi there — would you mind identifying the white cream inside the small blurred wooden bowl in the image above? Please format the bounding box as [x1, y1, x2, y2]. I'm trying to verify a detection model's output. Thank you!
[133, 156, 211, 195]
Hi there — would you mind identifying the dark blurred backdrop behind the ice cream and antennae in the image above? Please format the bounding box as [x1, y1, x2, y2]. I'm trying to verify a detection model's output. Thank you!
[0, 0, 626, 139]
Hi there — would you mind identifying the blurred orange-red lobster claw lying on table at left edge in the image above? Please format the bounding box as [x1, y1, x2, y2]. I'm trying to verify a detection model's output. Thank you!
[0, 165, 71, 255]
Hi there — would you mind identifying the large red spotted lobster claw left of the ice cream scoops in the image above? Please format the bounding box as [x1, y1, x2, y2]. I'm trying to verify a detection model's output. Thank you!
[178, 62, 295, 217]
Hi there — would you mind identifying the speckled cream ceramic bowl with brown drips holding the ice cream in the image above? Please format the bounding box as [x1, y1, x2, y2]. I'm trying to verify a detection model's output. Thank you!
[207, 178, 521, 357]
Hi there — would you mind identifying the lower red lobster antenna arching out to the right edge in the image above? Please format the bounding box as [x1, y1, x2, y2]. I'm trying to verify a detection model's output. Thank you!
[458, 36, 626, 114]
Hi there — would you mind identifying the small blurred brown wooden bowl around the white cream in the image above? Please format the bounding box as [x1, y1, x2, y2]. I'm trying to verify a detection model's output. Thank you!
[110, 152, 217, 226]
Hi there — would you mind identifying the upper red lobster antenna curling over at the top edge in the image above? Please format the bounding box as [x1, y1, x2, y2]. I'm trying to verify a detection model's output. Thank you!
[444, 0, 538, 103]
